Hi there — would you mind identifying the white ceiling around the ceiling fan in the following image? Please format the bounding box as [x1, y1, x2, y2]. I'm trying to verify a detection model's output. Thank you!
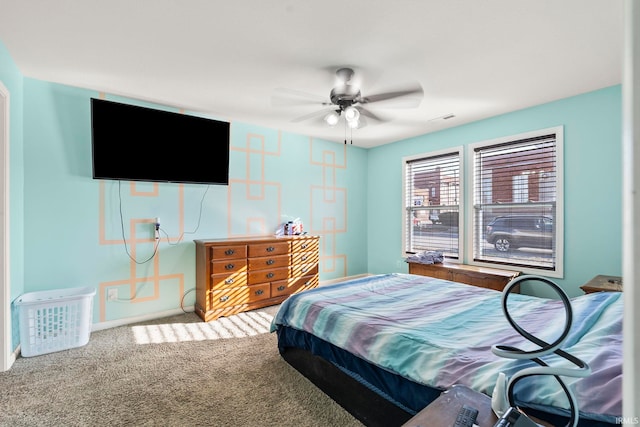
[0, 0, 623, 147]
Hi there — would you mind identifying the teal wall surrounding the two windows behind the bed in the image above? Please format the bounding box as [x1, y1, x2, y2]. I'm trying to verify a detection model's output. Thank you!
[367, 86, 622, 296]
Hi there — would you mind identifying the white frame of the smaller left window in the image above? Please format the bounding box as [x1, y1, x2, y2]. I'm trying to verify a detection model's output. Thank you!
[400, 145, 466, 263]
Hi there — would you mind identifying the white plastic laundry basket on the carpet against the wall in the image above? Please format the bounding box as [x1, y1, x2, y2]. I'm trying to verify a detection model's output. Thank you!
[15, 287, 96, 357]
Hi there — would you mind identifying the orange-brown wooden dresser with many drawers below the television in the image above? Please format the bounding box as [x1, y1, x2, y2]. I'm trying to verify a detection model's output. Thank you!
[195, 235, 320, 322]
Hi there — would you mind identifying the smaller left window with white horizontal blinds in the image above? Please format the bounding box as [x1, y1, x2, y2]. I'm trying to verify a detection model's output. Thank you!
[403, 149, 461, 258]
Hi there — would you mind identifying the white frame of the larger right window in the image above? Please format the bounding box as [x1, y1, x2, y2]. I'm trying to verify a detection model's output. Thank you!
[463, 126, 564, 278]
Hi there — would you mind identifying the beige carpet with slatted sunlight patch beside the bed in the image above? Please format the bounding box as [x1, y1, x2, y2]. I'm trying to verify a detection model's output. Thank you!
[0, 307, 362, 427]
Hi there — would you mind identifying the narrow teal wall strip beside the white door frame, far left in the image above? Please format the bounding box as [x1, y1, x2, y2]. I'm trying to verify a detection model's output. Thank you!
[0, 41, 24, 346]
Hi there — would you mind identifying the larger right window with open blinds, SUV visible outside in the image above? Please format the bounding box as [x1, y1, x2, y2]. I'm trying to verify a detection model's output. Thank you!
[470, 128, 563, 277]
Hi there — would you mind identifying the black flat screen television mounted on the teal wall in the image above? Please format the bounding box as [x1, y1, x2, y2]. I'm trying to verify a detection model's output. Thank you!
[91, 98, 230, 185]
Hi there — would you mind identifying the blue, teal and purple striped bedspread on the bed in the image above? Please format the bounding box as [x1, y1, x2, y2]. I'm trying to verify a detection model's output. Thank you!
[271, 274, 622, 422]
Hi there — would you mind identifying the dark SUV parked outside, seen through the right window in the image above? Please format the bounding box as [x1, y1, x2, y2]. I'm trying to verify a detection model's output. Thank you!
[485, 215, 554, 252]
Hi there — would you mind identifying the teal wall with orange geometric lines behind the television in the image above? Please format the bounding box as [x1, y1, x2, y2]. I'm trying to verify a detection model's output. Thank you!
[24, 78, 367, 322]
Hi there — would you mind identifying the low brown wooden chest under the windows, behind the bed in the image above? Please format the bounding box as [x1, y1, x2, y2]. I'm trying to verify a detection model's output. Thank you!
[408, 262, 520, 291]
